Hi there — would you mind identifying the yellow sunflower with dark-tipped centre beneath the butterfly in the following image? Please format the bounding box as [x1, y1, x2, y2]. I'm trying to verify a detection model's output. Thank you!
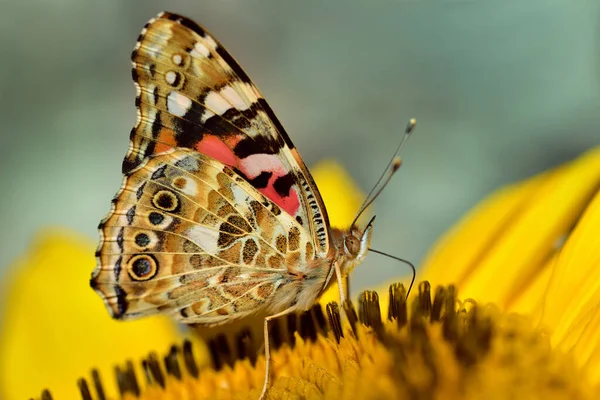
[0, 150, 600, 400]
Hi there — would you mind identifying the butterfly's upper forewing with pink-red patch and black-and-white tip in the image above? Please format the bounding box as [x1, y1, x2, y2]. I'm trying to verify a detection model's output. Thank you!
[123, 13, 333, 257]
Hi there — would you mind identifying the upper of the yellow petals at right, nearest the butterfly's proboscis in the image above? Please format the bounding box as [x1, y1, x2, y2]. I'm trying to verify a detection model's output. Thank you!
[421, 149, 600, 311]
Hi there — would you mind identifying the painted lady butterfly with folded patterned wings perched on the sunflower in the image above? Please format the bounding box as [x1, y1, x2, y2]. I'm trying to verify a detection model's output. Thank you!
[90, 12, 412, 396]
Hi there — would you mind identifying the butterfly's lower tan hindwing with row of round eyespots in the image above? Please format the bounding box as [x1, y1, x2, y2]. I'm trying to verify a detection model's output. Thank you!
[92, 149, 315, 325]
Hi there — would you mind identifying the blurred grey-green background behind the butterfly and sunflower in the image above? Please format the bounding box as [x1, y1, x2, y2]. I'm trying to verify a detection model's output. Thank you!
[0, 0, 600, 289]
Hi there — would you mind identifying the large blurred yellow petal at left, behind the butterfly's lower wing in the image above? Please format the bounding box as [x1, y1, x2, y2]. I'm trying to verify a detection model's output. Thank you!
[0, 230, 207, 400]
